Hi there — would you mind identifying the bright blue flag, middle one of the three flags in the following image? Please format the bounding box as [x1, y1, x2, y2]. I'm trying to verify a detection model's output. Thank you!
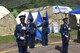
[36, 11, 43, 40]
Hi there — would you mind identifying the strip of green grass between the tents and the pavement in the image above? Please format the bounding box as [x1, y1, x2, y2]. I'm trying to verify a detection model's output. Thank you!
[0, 30, 77, 43]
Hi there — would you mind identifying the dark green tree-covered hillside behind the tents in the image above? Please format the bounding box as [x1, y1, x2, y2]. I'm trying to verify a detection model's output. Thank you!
[0, 0, 80, 16]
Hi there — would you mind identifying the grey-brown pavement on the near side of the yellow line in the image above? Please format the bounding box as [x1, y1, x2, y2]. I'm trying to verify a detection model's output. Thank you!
[0, 41, 80, 53]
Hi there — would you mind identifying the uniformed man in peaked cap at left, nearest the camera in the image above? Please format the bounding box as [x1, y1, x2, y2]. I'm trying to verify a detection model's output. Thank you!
[14, 15, 28, 53]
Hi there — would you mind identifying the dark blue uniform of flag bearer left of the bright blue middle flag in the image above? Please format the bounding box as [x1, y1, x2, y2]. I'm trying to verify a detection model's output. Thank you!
[28, 22, 36, 48]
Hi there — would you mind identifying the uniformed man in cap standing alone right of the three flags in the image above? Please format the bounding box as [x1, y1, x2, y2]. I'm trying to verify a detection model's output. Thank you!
[60, 18, 71, 53]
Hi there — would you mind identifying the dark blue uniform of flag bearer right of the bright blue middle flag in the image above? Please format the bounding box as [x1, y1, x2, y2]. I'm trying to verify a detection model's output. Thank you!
[42, 21, 49, 46]
